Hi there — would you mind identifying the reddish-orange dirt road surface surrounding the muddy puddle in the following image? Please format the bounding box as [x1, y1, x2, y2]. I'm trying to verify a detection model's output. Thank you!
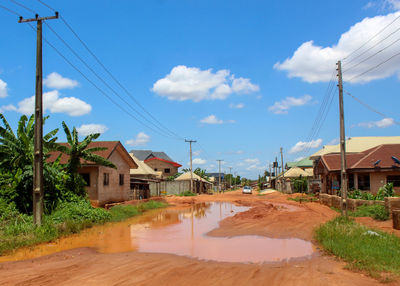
[0, 192, 397, 286]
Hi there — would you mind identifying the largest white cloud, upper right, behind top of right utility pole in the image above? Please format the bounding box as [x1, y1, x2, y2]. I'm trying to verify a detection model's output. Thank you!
[274, 11, 400, 83]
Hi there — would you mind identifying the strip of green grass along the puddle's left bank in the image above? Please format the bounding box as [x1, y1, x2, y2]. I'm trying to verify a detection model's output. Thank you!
[0, 200, 167, 255]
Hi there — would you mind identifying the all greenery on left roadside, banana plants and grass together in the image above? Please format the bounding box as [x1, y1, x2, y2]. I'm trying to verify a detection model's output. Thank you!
[0, 114, 165, 255]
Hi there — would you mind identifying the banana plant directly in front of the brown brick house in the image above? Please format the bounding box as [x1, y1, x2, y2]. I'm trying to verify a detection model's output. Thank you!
[58, 121, 117, 196]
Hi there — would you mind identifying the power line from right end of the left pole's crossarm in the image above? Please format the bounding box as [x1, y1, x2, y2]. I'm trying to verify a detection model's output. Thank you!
[38, 0, 184, 140]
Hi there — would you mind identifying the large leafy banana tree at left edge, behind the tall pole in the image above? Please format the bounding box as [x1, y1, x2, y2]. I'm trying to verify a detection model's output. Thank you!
[0, 114, 60, 213]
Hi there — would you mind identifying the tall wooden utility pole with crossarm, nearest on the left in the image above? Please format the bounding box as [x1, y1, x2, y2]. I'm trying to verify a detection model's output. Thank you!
[18, 12, 58, 225]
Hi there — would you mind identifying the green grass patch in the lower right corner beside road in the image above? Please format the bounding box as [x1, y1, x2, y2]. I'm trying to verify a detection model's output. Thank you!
[315, 217, 400, 279]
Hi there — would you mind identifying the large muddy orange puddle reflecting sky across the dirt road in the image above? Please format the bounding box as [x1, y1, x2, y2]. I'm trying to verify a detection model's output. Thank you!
[0, 202, 314, 263]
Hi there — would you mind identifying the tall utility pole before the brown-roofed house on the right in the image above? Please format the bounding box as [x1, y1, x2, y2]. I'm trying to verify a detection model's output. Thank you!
[337, 61, 348, 216]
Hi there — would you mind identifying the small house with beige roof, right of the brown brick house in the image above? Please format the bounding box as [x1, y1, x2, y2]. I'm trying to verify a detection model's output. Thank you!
[129, 153, 161, 200]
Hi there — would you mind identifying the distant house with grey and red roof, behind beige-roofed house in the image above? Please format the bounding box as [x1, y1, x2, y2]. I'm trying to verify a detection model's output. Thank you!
[131, 150, 182, 179]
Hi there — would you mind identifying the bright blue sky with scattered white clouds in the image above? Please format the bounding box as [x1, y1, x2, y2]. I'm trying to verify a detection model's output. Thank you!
[0, 0, 400, 178]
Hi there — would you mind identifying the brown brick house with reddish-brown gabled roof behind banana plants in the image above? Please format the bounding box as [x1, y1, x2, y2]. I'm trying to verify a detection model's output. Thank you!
[47, 141, 138, 206]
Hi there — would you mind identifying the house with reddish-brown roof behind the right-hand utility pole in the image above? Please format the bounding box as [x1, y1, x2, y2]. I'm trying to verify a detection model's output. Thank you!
[314, 144, 400, 194]
